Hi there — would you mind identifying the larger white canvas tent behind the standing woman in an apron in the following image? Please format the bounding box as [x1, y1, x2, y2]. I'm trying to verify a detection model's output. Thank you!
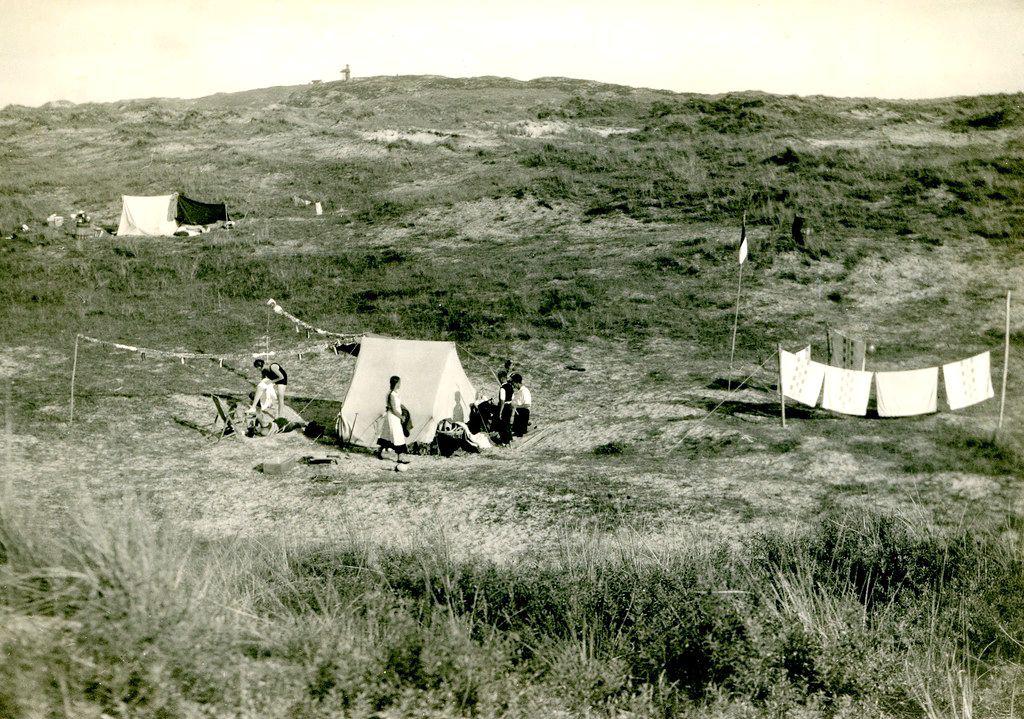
[340, 336, 476, 448]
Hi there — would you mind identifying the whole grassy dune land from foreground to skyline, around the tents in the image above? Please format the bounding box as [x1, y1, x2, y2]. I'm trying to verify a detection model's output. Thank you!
[0, 77, 1024, 719]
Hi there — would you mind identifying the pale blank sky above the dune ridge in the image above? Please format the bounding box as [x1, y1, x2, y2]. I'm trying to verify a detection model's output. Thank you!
[0, 0, 1024, 107]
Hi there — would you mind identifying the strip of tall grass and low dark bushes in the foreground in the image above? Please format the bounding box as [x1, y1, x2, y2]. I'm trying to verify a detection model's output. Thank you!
[0, 495, 1024, 717]
